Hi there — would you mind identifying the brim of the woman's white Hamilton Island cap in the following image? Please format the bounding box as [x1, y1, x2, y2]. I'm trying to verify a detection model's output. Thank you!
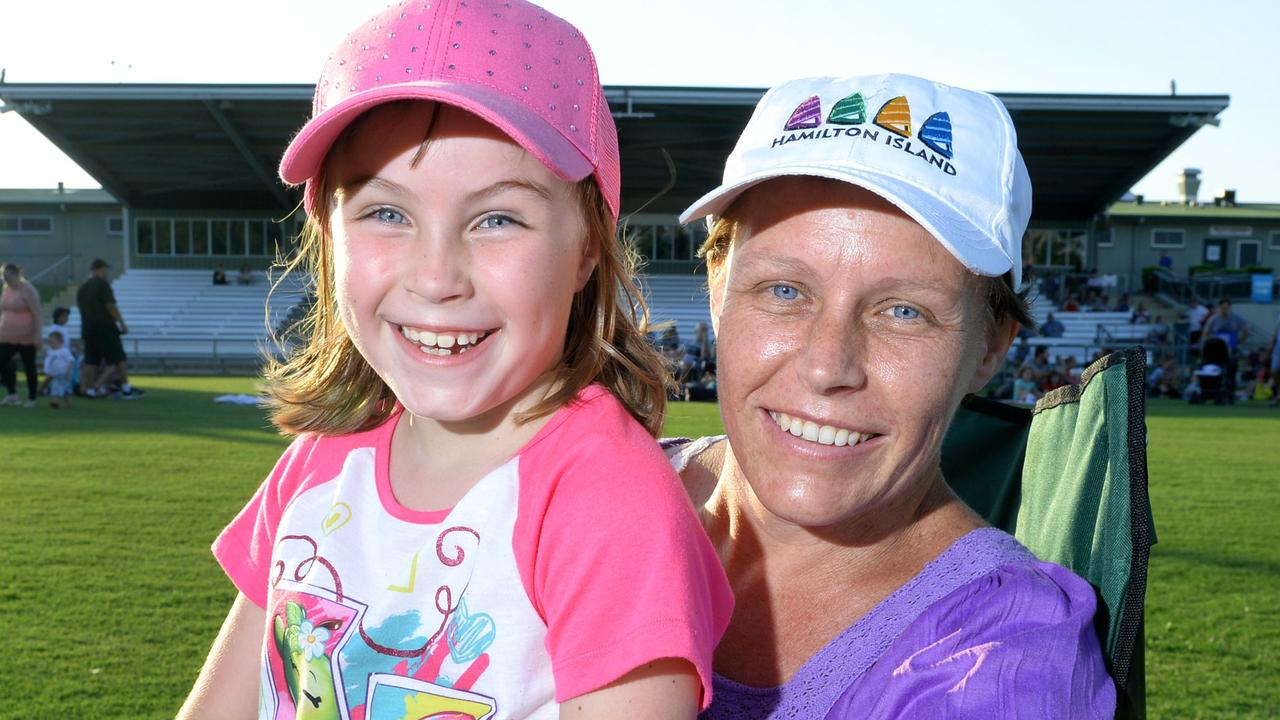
[680, 163, 1021, 279]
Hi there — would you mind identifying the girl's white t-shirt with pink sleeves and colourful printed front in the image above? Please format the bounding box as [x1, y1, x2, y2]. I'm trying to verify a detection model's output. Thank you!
[214, 386, 733, 720]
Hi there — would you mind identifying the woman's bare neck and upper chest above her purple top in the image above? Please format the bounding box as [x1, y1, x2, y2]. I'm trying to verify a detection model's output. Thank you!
[686, 442, 983, 687]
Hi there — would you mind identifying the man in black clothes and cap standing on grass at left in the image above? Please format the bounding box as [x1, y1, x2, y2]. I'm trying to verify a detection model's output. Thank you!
[76, 258, 142, 398]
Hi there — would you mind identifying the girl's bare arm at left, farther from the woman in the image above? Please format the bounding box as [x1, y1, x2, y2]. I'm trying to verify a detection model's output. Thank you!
[178, 593, 266, 720]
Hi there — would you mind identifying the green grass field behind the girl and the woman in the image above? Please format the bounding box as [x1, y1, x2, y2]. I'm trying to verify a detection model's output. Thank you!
[0, 377, 1280, 720]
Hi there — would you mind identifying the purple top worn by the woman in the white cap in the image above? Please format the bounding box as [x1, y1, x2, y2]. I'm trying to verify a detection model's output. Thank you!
[700, 528, 1116, 720]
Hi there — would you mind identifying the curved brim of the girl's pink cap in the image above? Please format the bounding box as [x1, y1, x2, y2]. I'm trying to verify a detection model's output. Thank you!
[280, 81, 594, 184]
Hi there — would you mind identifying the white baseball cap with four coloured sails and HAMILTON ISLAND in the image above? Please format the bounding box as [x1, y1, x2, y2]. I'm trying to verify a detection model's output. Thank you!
[680, 74, 1032, 287]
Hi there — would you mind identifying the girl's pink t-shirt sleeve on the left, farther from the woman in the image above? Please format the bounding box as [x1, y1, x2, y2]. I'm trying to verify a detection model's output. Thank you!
[214, 436, 319, 607]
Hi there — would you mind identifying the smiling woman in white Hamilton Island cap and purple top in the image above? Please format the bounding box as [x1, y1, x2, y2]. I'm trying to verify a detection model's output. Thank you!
[669, 76, 1115, 719]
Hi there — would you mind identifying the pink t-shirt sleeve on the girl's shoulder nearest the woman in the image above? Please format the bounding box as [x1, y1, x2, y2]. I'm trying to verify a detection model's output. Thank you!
[516, 393, 733, 708]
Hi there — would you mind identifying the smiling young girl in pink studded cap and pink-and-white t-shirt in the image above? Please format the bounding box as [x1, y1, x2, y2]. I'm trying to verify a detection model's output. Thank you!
[182, 0, 732, 720]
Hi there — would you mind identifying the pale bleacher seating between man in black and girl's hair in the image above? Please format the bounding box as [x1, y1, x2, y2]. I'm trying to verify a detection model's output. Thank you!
[68, 269, 302, 361]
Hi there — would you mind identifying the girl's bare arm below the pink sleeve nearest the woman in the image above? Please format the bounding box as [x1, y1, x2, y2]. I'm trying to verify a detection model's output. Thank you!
[561, 657, 703, 720]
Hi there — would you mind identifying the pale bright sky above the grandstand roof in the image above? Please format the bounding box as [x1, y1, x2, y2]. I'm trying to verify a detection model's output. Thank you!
[0, 0, 1280, 202]
